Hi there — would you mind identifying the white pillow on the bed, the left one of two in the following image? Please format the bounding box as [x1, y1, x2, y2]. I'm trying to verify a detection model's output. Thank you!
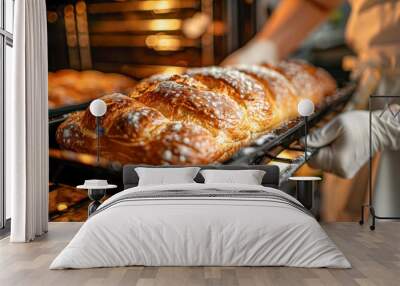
[135, 167, 200, 186]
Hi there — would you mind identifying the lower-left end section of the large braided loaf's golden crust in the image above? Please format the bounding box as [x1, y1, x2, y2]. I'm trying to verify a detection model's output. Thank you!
[56, 94, 220, 164]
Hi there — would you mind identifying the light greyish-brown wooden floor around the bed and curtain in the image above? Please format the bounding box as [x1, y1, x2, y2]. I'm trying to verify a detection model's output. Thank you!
[0, 222, 400, 286]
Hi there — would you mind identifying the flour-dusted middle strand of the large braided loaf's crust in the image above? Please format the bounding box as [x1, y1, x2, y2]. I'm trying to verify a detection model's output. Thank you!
[136, 76, 249, 141]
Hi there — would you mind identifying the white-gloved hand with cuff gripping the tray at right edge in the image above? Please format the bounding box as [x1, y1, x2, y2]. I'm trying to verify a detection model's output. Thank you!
[307, 105, 400, 178]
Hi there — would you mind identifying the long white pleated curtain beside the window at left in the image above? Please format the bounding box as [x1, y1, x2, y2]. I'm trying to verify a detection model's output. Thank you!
[5, 0, 48, 242]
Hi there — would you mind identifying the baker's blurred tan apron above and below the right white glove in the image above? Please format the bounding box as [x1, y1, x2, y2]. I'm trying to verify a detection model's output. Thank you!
[322, 0, 400, 221]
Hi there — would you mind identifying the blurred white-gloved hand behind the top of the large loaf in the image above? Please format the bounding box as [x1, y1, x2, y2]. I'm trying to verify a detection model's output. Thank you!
[221, 39, 278, 66]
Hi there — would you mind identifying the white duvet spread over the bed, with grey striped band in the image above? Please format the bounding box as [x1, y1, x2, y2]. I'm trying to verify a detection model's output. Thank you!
[50, 184, 350, 269]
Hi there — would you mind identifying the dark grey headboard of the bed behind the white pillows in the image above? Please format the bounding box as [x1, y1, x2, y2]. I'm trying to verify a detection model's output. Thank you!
[123, 165, 279, 189]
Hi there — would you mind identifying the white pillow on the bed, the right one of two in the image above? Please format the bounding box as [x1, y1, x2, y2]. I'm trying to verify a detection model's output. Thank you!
[200, 170, 265, 185]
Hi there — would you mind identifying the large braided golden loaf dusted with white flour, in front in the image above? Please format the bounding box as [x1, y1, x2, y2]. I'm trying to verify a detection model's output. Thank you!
[56, 61, 336, 165]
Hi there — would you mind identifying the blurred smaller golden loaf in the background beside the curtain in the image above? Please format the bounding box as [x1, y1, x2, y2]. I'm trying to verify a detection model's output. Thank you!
[48, 70, 136, 108]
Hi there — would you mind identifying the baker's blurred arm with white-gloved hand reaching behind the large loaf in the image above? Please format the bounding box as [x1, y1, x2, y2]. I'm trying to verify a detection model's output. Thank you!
[222, 0, 342, 65]
